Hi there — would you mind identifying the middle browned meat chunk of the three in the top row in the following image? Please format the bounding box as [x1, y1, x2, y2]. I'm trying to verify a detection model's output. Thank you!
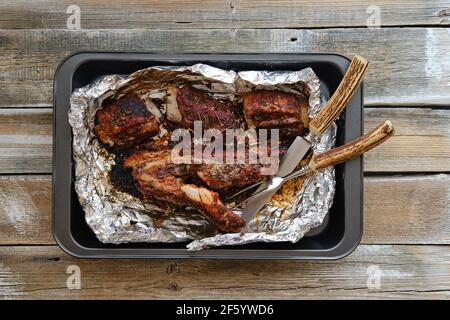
[176, 85, 239, 131]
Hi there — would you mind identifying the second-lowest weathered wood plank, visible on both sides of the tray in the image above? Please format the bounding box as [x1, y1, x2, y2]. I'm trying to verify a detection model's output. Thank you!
[0, 174, 450, 245]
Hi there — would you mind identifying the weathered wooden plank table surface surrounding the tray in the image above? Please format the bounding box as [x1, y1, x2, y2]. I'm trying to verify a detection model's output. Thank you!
[0, 0, 450, 299]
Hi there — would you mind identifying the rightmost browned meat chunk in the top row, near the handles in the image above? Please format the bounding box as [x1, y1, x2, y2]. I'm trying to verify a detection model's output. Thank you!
[243, 90, 308, 136]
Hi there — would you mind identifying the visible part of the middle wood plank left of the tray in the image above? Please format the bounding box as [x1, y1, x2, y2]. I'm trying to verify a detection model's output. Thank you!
[0, 109, 53, 173]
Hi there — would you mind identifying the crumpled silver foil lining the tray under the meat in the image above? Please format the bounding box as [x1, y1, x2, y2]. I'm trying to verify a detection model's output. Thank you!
[69, 64, 336, 250]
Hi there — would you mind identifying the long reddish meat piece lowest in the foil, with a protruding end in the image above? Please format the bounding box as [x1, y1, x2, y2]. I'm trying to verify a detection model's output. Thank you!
[124, 150, 245, 232]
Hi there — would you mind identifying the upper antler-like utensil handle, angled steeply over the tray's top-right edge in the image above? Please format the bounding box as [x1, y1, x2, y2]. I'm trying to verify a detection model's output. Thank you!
[309, 55, 369, 135]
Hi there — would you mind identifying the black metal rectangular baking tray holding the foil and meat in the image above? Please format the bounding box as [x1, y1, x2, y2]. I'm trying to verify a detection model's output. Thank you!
[52, 52, 363, 260]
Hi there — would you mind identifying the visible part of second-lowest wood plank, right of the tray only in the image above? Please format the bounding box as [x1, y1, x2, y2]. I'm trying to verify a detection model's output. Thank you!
[362, 174, 450, 244]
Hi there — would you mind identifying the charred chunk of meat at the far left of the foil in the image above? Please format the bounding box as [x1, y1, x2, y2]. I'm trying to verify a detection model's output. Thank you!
[95, 95, 159, 149]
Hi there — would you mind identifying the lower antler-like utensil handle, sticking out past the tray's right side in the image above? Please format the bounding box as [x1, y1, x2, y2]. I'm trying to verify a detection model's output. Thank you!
[309, 120, 394, 171]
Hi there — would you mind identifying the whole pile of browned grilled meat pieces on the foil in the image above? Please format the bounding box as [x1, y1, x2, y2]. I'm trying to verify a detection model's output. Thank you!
[99, 85, 308, 232]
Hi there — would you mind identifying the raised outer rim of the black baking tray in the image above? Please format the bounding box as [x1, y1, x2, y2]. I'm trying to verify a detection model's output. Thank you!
[52, 50, 364, 260]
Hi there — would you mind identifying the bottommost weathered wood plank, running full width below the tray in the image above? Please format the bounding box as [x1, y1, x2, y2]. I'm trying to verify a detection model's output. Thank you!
[0, 245, 450, 299]
